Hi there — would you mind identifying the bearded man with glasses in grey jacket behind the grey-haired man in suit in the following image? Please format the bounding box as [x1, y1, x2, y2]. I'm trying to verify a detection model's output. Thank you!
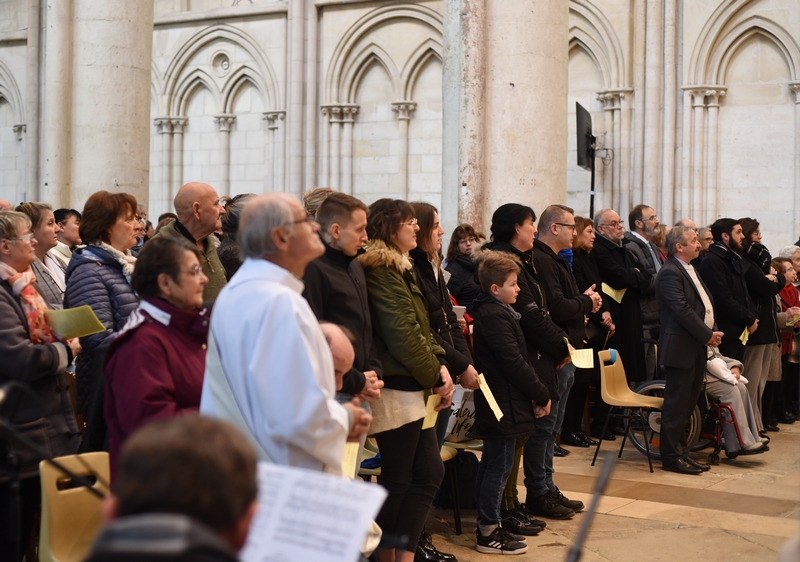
[624, 205, 661, 380]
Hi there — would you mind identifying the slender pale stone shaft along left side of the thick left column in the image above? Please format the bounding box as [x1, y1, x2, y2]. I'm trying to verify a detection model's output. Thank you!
[42, 0, 72, 209]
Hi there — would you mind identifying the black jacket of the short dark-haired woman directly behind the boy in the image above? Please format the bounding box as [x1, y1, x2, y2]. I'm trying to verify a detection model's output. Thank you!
[476, 242, 569, 400]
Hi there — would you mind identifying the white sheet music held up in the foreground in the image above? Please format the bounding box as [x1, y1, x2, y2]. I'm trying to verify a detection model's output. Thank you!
[240, 462, 386, 562]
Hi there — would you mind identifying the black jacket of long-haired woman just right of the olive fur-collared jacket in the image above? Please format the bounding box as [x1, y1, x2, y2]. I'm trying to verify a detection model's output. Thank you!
[408, 248, 472, 379]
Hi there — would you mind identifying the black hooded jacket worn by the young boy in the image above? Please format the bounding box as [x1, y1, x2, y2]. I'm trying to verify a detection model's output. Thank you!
[469, 293, 550, 439]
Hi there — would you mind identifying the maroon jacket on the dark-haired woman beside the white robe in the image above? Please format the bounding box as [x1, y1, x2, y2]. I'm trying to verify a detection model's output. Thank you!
[103, 299, 210, 474]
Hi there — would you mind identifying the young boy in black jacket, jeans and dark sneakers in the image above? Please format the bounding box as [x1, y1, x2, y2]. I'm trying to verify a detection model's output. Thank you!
[470, 252, 550, 554]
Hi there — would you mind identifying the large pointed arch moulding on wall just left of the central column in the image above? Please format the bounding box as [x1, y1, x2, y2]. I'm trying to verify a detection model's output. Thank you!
[324, 4, 443, 104]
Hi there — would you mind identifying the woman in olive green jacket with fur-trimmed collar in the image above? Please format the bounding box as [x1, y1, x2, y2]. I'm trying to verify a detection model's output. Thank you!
[358, 199, 453, 562]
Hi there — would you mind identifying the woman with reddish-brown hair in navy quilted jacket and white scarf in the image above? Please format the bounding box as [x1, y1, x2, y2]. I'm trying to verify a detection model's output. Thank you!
[64, 191, 139, 438]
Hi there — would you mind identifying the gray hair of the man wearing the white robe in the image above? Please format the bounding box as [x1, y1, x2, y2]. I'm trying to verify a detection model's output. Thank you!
[237, 193, 294, 260]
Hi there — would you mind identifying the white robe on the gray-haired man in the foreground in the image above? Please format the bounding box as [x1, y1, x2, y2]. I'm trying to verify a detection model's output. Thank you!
[200, 259, 350, 474]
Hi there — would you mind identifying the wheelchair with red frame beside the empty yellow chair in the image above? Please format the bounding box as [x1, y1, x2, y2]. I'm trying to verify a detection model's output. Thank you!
[626, 379, 742, 465]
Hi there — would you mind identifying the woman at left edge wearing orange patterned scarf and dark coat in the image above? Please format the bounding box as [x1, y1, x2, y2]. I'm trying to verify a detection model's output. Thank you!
[0, 211, 80, 555]
